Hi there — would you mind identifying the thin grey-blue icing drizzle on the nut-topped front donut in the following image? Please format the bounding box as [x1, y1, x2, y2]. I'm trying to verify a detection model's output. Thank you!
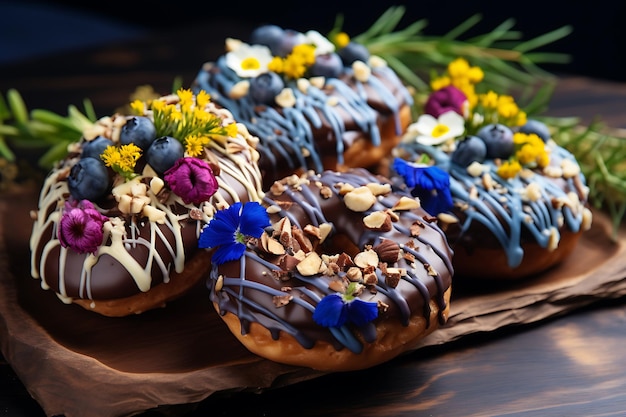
[209, 170, 452, 354]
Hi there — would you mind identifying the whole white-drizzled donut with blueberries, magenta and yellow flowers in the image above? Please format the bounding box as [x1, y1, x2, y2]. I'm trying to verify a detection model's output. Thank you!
[30, 89, 262, 317]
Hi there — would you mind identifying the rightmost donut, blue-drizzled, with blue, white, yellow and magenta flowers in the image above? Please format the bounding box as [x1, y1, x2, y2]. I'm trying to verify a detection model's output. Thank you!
[389, 60, 593, 282]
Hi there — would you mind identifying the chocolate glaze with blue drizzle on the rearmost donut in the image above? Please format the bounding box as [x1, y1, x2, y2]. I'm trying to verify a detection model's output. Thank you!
[191, 30, 413, 188]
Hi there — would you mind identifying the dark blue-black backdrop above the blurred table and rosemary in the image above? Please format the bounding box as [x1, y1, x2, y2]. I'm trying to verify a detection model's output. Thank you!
[0, 0, 626, 81]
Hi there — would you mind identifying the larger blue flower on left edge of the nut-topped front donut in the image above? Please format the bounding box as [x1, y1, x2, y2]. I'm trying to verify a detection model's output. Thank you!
[198, 201, 270, 265]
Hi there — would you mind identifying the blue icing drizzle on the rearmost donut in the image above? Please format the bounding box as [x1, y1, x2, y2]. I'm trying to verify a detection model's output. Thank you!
[192, 35, 413, 179]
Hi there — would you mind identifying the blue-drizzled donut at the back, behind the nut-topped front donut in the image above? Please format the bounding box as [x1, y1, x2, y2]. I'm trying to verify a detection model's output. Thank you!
[191, 25, 413, 189]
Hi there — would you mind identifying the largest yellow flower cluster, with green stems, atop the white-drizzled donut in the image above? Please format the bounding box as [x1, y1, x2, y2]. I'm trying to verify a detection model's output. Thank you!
[131, 88, 237, 156]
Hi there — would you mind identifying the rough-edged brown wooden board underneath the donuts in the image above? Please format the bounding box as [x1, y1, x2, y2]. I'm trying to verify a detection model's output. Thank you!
[0, 187, 626, 417]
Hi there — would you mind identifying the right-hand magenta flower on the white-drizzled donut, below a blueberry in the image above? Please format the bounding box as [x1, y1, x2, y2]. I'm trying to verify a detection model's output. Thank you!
[165, 157, 219, 204]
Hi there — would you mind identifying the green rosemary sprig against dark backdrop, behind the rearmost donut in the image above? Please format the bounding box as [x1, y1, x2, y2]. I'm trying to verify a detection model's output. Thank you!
[342, 6, 572, 97]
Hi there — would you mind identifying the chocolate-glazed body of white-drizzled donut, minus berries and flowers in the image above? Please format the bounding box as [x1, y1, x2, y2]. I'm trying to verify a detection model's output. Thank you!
[30, 96, 263, 316]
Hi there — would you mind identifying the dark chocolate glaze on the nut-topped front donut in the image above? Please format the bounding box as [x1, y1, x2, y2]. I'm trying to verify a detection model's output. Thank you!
[209, 169, 453, 353]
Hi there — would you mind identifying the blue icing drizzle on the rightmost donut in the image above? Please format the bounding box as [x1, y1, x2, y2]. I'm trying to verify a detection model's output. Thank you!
[399, 138, 585, 268]
